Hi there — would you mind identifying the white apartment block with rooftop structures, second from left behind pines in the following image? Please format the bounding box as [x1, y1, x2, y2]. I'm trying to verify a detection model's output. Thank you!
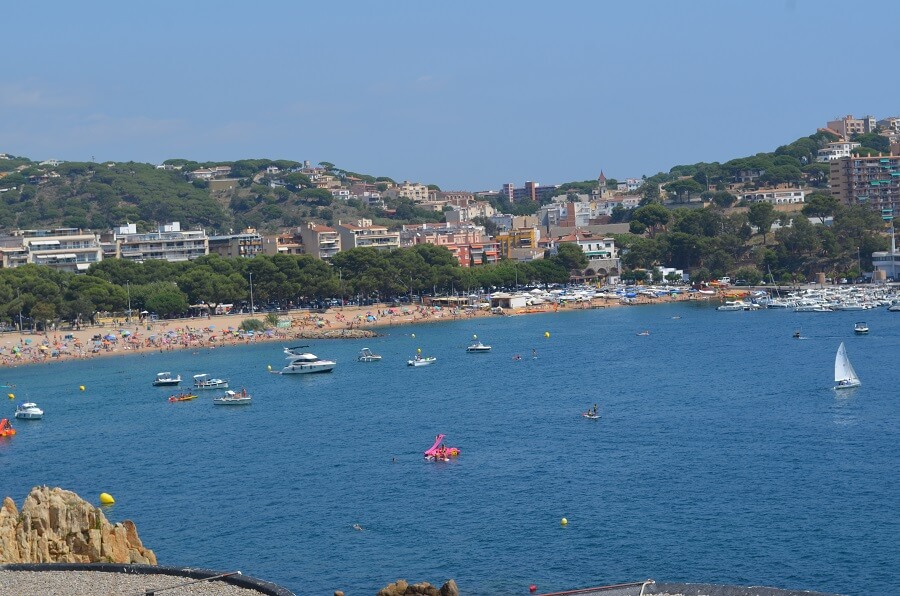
[114, 221, 209, 263]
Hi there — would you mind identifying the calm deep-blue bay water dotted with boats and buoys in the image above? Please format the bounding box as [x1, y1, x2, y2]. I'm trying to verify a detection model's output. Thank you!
[0, 304, 900, 594]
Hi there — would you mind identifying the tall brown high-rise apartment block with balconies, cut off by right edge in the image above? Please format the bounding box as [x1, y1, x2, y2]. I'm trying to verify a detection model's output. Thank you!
[829, 155, 900, 214]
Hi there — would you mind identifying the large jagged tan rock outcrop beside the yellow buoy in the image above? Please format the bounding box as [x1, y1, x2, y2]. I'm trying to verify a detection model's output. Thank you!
[0, 486, 156, 565]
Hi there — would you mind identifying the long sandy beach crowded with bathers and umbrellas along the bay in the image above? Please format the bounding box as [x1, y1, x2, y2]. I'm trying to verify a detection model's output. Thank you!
[0, 294, 708, 367]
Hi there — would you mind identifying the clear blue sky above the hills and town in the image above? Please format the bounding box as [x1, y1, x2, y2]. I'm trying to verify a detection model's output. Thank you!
[7, 0, 900, 190]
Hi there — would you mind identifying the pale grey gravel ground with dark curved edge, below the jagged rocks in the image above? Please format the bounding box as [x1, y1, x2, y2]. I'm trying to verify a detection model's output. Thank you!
[0, 571, 278, 596]
